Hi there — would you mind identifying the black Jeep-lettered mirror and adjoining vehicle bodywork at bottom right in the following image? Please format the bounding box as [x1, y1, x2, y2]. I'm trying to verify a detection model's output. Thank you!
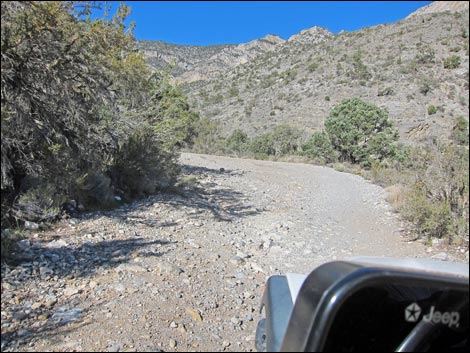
[257, 258, 469, 352]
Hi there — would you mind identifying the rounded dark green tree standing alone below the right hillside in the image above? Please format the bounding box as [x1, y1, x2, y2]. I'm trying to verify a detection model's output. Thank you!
[325, 98, 398, 166]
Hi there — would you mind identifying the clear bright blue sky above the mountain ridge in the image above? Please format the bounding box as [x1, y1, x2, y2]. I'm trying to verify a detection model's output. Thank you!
[112, 1, 431, 45]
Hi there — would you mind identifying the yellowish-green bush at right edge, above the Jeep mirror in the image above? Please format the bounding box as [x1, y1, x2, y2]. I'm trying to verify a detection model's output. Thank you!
[401, 144, 469, 243]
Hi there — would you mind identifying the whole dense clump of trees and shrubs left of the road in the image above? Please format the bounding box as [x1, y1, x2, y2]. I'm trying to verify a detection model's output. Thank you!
[1, 1, 198, 226]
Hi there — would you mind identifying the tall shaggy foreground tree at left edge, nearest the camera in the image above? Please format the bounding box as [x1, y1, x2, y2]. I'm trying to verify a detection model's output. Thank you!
[1, 1, 148, 222]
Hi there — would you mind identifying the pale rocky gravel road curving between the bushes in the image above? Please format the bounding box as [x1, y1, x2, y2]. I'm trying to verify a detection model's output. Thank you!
[1, 154, 458, 352]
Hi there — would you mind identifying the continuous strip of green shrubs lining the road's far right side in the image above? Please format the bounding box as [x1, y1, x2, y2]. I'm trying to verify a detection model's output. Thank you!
[193, 98, 469, 245]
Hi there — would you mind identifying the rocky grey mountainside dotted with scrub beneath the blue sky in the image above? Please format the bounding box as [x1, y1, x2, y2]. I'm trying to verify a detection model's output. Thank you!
[140, 2, 469, 144]
